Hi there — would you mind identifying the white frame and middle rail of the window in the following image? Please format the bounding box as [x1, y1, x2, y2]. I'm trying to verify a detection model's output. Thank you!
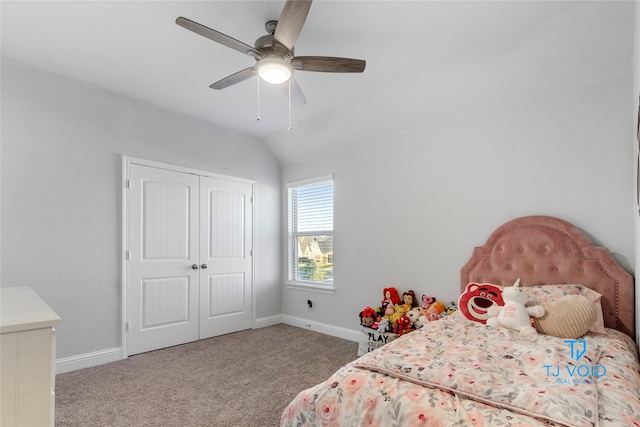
[285, 174, 335, 294]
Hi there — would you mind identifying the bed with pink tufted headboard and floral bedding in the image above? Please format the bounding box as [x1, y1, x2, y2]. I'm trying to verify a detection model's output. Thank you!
[281, 216, 640, 426]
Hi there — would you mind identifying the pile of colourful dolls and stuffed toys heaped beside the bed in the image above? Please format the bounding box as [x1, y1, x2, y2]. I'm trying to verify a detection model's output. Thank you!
[360, 287, 457, 335]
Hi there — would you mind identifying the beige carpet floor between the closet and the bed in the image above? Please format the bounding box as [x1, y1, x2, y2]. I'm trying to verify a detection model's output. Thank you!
[56, 324, 358, 427]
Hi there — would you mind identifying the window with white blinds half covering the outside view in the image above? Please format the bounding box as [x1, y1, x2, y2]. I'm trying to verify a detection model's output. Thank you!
[288, 176, 333, 289]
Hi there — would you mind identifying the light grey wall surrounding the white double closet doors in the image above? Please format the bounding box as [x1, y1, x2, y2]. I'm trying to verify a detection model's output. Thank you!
[0, 61, 281, 359]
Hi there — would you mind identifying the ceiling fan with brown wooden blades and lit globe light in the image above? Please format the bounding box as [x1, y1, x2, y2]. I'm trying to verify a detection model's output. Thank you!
[176, 0, 366, 105]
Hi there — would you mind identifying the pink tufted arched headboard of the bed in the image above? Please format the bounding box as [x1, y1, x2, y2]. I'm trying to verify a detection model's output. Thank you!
[460, 216, 635, 339]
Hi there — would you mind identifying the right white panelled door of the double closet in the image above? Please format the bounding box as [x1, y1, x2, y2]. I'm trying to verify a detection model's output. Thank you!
[200, 176, 253, 338]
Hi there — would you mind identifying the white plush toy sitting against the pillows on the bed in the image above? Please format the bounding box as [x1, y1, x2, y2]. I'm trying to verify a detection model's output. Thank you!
[487, 279, 544, 334]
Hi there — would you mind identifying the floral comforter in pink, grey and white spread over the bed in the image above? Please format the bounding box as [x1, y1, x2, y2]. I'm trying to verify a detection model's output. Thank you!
[281, 316, 640, 427]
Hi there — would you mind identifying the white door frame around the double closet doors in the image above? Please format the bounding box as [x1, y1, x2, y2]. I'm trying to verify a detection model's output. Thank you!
[118, 155, 257, 359]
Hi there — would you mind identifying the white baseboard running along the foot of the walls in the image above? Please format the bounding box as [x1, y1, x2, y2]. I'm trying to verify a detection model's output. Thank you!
[56, 314, 360, 374]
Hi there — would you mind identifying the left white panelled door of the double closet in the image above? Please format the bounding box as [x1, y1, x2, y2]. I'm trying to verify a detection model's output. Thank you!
[126, 164, 200, 355]
